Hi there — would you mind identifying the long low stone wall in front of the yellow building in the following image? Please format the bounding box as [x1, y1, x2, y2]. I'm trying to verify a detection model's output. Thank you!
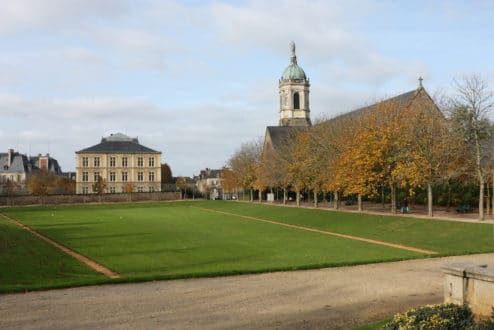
[0, 192, 180, 206]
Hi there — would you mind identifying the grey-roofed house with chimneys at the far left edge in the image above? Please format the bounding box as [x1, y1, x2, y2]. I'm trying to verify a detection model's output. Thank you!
[0, 149, 62, 193]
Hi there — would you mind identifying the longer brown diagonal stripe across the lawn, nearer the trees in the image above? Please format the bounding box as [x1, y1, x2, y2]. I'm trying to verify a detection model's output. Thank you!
[190, 206, 439, 254]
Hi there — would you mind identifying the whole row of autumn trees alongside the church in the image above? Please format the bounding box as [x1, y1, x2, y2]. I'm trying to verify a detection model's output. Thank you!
[223, 75, 494, 219]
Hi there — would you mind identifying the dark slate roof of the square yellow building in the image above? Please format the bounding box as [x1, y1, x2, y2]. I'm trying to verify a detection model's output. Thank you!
[76, 133, 161, 154]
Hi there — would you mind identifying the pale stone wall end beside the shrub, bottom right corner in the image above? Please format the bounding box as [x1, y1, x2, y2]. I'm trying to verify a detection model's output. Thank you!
[443, 263, 494, 318]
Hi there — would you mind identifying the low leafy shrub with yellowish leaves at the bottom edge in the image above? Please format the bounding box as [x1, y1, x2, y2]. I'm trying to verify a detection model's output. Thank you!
[383, 304, 475, 330]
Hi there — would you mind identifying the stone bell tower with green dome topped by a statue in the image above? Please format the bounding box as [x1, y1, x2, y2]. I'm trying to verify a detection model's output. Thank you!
[279, 41, 311, 126]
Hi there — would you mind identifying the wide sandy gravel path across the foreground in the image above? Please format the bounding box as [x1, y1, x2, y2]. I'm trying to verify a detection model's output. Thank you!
[0, 254, 494, 329]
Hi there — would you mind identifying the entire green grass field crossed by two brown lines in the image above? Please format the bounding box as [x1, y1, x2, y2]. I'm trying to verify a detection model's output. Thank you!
[0, 201, 494, 292]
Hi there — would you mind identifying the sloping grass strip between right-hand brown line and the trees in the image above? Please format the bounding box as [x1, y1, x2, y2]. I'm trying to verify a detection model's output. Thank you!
[200, 203, 494, 256]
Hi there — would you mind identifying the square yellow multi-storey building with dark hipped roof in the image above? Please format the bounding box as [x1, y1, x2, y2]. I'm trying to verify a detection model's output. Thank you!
[76, 133, 161, 194]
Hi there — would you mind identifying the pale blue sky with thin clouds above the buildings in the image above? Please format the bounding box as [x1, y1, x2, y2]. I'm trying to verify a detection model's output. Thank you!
[0, 0, 494, 176]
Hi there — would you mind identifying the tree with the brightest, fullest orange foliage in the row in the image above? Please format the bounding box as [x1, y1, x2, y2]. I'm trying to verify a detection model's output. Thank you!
[338, 100, 411, 213]
